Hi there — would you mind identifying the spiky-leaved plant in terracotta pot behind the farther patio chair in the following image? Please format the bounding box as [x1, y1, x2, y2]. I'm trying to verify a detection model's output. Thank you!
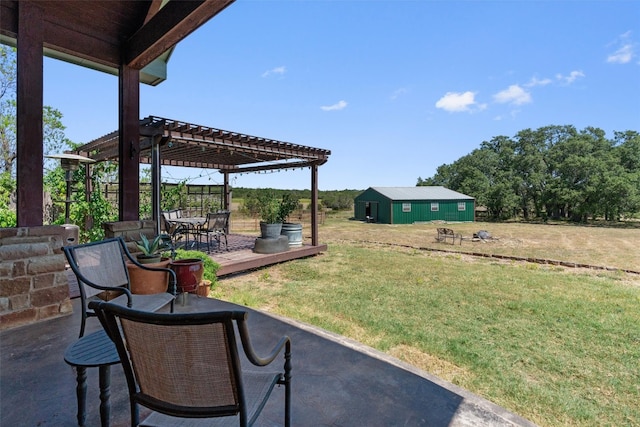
[127, 234, 171, 294]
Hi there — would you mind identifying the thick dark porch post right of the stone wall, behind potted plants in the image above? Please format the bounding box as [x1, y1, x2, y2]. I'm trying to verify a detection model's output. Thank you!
[118, 64, 140, 221]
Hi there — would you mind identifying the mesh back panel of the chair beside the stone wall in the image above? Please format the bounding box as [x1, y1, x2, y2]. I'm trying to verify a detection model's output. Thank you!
[73, 240, 129, 298]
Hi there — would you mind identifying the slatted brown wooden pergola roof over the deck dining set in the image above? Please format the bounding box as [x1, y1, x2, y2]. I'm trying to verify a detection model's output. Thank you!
[74, 116, 331, 173]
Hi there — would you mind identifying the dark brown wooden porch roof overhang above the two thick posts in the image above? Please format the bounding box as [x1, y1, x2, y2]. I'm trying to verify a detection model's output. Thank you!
[0, 0, 234, 86]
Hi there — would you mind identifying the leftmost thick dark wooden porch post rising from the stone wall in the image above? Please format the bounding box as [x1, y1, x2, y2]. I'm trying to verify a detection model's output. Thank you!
[16, 1, 44, 227]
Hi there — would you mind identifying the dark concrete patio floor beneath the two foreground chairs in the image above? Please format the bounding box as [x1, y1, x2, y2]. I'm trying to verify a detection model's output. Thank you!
[0, 295, 534, 427]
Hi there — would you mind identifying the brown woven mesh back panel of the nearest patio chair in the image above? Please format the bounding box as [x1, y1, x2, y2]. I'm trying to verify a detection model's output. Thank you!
[121, 318, 239, 408]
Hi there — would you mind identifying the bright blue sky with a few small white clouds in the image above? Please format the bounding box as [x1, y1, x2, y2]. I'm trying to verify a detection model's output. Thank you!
[44, 0, 640, 190]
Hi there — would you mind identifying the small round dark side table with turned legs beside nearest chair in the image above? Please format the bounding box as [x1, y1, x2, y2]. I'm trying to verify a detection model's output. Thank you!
[64, 329, 120, 427]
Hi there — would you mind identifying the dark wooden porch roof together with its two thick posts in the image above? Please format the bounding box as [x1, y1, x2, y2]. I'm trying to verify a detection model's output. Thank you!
[0, 0, 234, 227]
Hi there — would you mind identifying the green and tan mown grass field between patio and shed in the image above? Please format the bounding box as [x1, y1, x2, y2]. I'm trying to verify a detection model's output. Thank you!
[215, 215, 640, 426]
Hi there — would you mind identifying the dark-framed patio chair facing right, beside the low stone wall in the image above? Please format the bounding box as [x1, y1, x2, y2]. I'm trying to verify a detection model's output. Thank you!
[62, 237, 176, 337]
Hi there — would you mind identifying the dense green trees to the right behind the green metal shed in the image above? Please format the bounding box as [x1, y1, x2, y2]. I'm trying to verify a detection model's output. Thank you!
[417, 125, 640, 222]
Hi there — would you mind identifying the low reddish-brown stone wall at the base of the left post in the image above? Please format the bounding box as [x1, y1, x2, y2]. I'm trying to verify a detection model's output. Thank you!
[0, 225, 78, 329]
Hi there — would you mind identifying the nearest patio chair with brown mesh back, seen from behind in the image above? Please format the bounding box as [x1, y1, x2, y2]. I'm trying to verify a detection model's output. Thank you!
[91, 302, 291, 427]
